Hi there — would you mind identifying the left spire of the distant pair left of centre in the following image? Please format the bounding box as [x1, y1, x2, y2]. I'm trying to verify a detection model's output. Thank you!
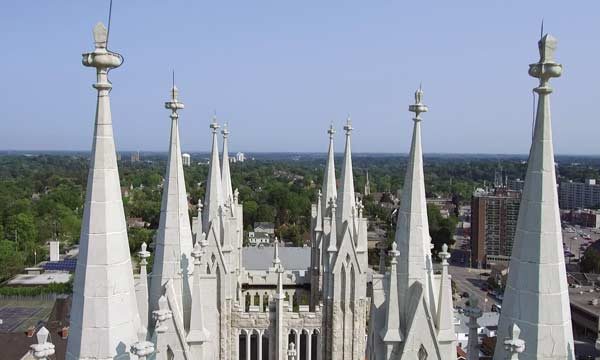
[202, 116, 223, 231]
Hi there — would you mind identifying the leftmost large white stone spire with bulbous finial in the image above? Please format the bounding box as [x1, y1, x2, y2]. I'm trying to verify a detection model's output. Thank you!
[66, 23, 141, 359]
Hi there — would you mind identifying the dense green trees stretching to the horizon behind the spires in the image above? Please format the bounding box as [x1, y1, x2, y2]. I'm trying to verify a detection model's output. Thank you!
[0, 154, 600, 280]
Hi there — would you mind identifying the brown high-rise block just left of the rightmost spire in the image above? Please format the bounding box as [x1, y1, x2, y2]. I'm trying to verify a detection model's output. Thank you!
[471, 187, 521, 267]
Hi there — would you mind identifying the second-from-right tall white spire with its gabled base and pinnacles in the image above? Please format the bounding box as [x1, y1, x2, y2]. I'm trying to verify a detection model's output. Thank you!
[368, 88, 456, 360]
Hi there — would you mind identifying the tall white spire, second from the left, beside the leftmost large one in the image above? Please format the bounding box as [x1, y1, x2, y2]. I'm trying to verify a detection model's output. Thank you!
[150, 84, 194, 358]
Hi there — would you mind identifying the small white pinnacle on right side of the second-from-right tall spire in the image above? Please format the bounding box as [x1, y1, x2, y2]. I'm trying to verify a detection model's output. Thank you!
[435, 244, 456, 342]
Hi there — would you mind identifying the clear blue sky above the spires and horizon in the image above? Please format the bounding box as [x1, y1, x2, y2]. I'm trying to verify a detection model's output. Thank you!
[0, 0, 600, 155]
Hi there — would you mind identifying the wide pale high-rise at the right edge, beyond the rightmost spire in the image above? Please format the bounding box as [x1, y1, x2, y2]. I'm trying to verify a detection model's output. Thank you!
[558, 179, 600, 209]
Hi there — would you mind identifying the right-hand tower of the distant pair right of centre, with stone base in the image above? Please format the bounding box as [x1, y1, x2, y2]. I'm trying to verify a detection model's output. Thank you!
[322, 119, 368, 360]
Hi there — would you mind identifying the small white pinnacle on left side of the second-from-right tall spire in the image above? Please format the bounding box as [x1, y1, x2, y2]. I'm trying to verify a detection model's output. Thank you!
[381, 242, 404, 359]
